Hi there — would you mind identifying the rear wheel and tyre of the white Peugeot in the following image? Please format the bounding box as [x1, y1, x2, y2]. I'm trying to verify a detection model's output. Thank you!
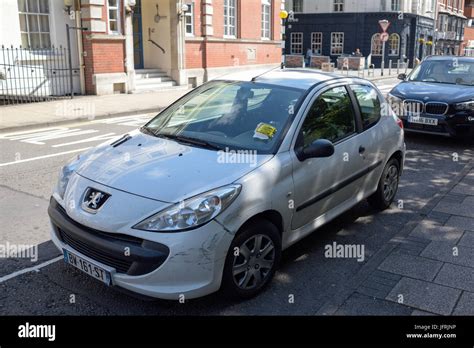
[367, 158, 400, 210]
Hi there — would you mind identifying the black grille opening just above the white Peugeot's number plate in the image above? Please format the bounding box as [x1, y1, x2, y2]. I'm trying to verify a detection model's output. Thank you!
[58, 228, 133, 273]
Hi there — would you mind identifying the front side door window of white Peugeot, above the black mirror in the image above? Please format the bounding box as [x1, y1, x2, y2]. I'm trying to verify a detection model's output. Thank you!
[299, 87, 356, 147]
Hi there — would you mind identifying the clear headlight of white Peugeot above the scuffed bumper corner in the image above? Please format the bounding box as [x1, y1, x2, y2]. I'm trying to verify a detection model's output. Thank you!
[133, 185, 241, 232]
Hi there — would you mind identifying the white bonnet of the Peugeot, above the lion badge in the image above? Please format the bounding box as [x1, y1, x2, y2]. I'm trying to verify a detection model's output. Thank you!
[76, 130, 273, 203]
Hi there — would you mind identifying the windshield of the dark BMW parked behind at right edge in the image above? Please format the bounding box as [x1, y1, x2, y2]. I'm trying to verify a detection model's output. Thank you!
[408, 57, 474, 86]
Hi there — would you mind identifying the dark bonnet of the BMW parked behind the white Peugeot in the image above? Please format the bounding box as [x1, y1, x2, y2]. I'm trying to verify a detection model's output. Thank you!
[390, 81, 474, 103]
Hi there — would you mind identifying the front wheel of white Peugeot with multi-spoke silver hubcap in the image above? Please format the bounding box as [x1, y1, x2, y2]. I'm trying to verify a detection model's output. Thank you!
[221, 219, 281, 299]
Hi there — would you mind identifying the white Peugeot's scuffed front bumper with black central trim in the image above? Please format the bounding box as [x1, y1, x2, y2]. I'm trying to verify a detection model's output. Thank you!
[48, 198, 233, 299]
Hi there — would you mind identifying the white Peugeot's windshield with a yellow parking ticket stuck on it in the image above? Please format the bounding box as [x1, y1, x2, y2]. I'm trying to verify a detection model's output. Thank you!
[144, 81, 304, 154]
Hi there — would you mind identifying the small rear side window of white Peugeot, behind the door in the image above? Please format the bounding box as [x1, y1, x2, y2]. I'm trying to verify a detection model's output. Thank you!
[351, 85, 381, 130]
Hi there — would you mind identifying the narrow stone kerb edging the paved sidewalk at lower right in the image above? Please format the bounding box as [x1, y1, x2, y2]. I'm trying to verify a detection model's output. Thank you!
[315, 159, 474, 315]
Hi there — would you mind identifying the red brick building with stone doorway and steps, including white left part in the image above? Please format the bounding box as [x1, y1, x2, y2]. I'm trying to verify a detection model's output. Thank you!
[0, 0, 284, 95]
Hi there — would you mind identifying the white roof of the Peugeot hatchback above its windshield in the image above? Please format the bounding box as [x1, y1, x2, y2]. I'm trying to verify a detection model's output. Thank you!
[212, 68, 361, 90]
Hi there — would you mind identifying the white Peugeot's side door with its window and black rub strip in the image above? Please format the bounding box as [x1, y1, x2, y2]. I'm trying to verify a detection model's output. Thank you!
[292, 85, 365, 230]
